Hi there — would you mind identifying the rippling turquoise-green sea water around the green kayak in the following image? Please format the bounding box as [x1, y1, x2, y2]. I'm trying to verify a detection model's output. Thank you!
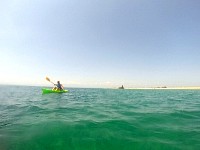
[0, 86, 200, 150]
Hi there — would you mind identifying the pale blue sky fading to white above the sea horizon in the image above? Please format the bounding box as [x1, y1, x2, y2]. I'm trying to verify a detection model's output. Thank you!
[0, 0, 200, 87]
